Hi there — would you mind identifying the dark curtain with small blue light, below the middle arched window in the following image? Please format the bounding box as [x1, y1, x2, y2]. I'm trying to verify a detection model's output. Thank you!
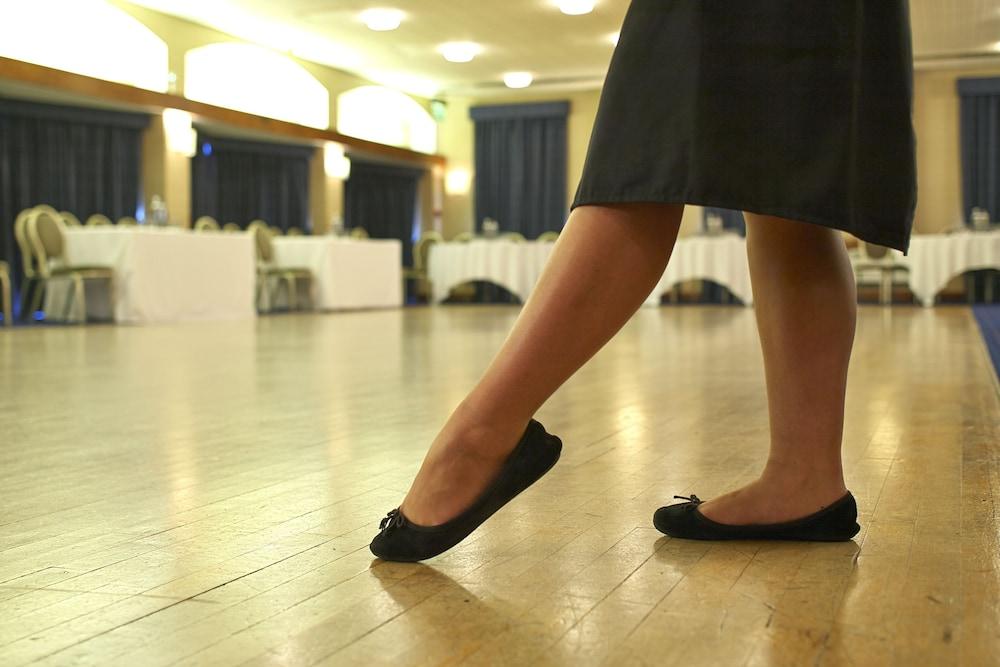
[191, 130, 316, 230]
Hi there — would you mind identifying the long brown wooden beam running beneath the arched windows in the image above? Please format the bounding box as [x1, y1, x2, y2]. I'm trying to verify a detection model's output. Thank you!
[0, 57, 447, 167]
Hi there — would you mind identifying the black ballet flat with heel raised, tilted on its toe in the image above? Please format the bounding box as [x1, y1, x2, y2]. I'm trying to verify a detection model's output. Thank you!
[371, 419, 562, 562]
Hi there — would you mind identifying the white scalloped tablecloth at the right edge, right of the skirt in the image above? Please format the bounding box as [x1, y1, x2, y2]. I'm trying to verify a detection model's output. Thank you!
[898, 231, 1000, 306]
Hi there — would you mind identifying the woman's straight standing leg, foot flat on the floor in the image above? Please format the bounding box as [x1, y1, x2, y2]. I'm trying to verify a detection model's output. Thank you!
[699, 213, 857, 525]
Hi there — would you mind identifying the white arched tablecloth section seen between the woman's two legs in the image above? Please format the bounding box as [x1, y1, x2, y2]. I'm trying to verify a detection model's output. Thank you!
[646, 234, 753, 306]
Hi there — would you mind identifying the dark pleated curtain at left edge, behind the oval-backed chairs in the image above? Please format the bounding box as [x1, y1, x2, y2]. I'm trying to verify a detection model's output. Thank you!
[0, 98, 149, 316]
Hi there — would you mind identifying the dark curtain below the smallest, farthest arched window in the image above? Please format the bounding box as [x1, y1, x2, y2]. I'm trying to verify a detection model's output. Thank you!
[344, 156, 424, 266]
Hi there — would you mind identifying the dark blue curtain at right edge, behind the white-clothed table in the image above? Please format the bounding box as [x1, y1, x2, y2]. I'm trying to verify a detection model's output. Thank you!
[958, 77, 1000, 301]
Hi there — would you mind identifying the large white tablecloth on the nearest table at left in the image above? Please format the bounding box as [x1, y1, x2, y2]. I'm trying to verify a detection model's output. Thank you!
[46, 227, 256, 324]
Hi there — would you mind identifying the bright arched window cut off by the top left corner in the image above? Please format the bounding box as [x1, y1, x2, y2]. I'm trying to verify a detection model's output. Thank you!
[0, 0, 169, 92]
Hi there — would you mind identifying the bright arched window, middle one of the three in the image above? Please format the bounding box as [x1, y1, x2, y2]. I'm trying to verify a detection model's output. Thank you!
[184, 43, 330, 130]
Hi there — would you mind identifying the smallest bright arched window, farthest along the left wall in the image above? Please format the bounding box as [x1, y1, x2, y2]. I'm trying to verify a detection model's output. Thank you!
[337, 86, 437, 153]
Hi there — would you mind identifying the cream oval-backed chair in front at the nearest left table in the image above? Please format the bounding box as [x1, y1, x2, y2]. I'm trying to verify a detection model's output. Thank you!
[27, 209, 114, 322]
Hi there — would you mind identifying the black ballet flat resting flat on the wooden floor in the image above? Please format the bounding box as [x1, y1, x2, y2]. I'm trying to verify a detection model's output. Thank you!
[653, 492, 861, 542]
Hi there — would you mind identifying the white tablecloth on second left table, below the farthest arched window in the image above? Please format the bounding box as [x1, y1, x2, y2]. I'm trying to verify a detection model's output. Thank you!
[274, 236, 403, 310]
